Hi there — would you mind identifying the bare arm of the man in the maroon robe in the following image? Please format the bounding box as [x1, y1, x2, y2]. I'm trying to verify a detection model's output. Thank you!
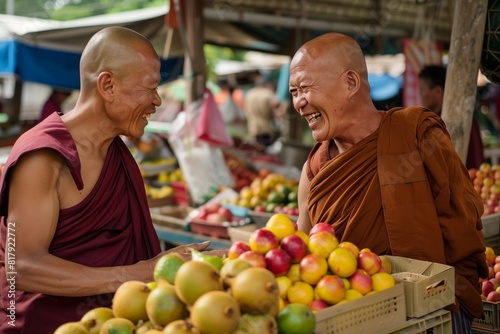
[9, 151, 208, 296]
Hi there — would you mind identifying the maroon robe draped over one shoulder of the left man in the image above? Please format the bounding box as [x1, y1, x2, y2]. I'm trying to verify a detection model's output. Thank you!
[0, 113, 161, 334]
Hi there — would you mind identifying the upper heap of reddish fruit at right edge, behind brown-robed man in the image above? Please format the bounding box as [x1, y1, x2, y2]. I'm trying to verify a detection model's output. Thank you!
[469, 163, 500, 215]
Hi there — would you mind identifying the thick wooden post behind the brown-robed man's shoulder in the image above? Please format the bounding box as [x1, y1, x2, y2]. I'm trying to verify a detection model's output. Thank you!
[442, 0, 488, 163]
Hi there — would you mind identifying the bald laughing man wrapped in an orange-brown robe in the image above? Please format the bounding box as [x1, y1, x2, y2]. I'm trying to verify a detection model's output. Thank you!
[289, 33, 488, 333]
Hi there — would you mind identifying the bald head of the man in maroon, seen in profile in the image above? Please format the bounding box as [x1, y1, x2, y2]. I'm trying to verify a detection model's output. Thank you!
[80, 27, 161, 138]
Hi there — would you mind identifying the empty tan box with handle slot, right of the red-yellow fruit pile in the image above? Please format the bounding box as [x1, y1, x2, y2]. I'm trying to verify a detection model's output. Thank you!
[387, 256, 455, 318]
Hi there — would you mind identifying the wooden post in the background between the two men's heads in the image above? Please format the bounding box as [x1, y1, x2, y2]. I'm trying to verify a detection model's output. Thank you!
[183, 0, 207, 108]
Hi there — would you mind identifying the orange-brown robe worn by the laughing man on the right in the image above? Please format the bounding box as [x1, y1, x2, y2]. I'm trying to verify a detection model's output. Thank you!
[307, 107, 487, 317]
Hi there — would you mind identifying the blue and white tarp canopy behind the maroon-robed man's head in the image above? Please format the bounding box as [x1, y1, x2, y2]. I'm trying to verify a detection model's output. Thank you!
[0, 9, 184, 89]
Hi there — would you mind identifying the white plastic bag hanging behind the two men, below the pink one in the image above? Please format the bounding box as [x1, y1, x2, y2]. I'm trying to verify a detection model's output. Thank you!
[168, 96, 234, 204]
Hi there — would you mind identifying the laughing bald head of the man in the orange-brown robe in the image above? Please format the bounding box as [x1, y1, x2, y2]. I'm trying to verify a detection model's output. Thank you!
[289, 33, 369, 142]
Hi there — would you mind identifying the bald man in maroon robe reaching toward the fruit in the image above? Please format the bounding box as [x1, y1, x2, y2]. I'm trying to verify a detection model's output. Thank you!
[0, 27, 213, 334]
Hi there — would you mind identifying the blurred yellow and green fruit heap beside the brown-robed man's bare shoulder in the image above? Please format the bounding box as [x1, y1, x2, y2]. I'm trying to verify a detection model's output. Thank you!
[225, 170, 298, 216]
